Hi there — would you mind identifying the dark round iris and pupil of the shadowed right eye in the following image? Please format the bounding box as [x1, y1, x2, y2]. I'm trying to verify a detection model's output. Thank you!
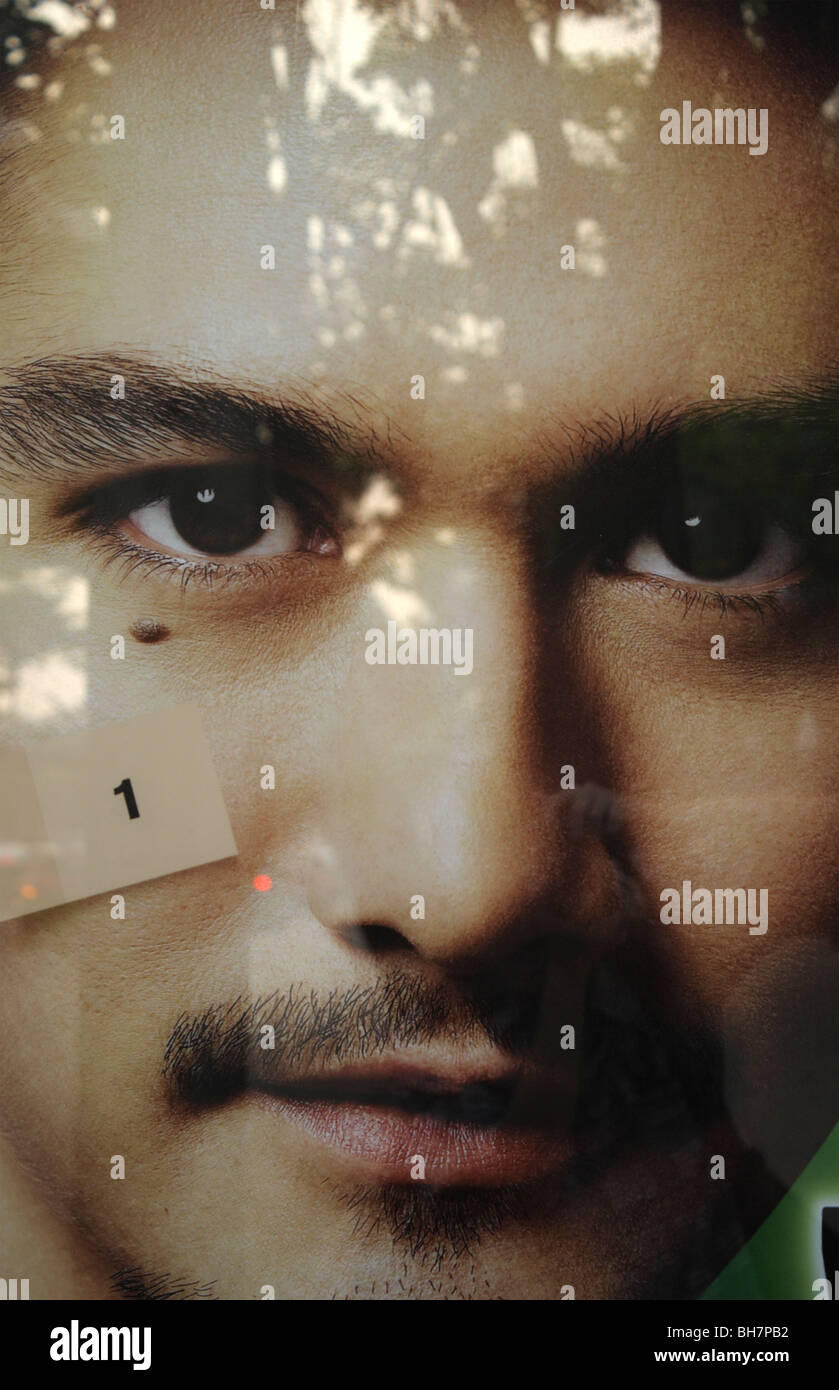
[656, 488, 763, 580]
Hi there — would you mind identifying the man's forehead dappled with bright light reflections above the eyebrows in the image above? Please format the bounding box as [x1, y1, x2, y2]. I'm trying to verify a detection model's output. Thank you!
[1, 0, 838, 475]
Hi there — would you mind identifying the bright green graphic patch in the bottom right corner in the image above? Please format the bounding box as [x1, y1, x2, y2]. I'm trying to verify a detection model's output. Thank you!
[701, 1125, 839, 1301]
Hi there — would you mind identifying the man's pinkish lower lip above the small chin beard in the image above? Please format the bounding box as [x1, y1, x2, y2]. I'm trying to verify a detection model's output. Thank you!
[253, 1094, 570, 1187]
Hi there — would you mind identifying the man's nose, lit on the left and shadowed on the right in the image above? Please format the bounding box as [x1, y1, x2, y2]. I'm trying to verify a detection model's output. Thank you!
[306, 530, 614, 966]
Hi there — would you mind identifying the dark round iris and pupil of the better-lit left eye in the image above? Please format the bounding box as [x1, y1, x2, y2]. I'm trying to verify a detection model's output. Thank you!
[169, 468, 271, 555]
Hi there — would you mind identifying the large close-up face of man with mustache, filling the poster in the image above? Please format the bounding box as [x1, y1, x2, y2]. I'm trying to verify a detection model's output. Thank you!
[0, 0, 839, 1298]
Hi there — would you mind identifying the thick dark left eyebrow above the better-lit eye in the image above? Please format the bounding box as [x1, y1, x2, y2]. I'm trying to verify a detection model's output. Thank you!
[0, 354, 404, 489]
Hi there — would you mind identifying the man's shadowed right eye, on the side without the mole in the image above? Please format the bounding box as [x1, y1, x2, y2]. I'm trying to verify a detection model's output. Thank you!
[622, 484, 807, 588]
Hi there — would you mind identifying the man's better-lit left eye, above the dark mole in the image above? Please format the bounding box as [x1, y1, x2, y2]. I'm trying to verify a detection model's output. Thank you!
[100, 466, 338, 562]
